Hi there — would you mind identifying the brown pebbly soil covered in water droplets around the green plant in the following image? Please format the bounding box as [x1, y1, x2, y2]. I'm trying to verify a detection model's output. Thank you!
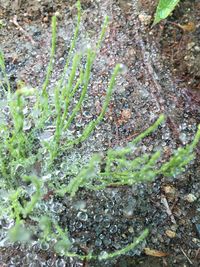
[0, 0, 200, 267]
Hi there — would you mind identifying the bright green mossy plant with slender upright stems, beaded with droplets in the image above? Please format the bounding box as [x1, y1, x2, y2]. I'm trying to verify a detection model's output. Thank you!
[0, 2, 200, 260]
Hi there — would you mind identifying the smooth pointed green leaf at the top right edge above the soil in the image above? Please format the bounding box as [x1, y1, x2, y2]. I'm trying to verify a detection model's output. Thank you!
[153, 0, 180, 26]
